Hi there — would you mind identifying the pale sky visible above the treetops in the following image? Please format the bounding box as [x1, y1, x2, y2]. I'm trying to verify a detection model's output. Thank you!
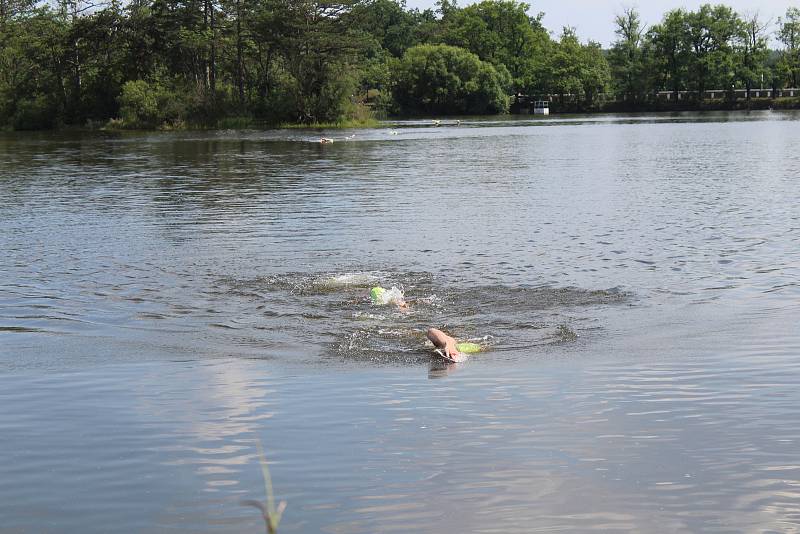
[406, 0, 800, 47]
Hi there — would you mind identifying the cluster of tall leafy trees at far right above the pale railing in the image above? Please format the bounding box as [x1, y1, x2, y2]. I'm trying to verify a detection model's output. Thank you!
[609, 4, 800, 100]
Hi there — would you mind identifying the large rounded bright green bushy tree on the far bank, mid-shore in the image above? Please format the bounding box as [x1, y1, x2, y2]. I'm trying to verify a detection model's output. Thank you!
[394, 45, 510, 114]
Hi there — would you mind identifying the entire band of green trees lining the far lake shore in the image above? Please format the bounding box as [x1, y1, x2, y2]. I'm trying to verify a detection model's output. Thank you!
[0, 0, 800, 129]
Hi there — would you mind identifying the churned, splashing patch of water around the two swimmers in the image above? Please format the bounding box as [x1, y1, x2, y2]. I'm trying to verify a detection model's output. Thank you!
[223, 270, 632, 364]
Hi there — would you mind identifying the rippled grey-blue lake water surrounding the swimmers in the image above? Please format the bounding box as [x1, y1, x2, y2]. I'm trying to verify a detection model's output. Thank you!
[0, 112, 800, 533]
